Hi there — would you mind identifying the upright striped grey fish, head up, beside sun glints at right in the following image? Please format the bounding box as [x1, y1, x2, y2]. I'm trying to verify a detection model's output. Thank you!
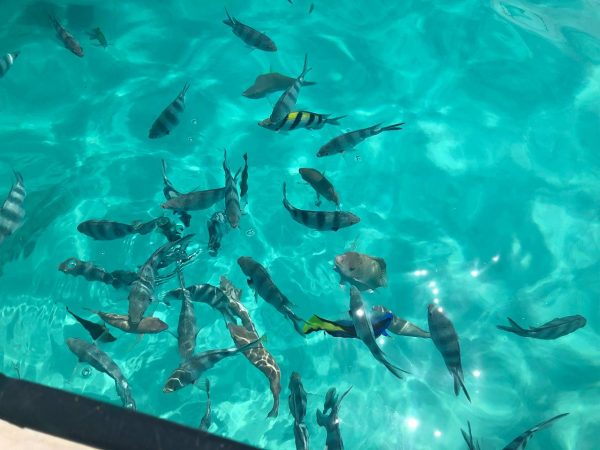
[427, 304, 471, 402]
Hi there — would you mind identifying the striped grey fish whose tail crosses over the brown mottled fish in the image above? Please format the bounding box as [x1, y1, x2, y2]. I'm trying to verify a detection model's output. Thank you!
[163, 336, 264, 394]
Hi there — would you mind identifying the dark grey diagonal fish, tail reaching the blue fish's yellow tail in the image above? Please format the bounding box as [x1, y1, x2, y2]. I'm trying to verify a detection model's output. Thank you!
[238, 256, 305, 337]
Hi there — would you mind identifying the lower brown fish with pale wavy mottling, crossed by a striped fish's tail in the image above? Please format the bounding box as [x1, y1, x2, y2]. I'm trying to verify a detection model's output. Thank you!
[227, 323, 281, 417]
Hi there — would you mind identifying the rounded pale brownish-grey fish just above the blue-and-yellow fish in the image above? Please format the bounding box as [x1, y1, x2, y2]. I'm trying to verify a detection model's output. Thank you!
[334, 252, 387, 291]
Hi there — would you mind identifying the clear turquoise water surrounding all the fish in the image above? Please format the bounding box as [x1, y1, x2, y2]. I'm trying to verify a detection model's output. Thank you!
[0, 0, 600, 450]
